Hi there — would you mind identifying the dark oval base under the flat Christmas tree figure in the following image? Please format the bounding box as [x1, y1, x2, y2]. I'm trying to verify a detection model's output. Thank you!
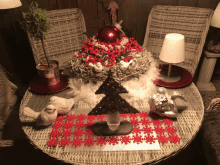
[92, 121, 133, 136]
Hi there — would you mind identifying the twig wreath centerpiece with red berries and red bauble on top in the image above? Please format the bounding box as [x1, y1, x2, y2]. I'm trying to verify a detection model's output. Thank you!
[63, 20, 156, 82]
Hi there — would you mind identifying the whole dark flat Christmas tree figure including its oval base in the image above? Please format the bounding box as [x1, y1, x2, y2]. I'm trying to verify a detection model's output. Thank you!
[88, 71, 139, 136]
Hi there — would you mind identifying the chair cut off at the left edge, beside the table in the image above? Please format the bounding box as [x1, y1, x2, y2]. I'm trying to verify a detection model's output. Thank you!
[0, 65, 18, 147]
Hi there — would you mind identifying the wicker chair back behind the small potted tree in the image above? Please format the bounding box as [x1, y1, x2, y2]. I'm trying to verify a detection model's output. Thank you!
[28, 8, 87, 66]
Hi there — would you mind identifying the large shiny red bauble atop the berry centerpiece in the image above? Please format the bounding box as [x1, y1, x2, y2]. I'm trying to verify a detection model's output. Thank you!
[97, 26, 121, 43]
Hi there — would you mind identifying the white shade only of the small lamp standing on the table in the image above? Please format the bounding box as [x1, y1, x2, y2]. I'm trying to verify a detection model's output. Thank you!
[159, 33, 185, 63]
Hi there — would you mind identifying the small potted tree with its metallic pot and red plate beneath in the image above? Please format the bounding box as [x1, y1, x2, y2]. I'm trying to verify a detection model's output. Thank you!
[20, 2, 68, 94]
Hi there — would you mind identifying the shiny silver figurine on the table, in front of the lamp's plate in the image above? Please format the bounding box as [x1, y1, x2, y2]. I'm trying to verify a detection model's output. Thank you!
[148, 87, 186, 118]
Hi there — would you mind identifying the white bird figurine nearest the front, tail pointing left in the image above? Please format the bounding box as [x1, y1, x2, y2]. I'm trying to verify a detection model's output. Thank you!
[23, 104, 57, 126]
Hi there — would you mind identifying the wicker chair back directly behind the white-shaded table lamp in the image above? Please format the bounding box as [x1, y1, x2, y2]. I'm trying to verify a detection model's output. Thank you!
[143, 5, 213, 75]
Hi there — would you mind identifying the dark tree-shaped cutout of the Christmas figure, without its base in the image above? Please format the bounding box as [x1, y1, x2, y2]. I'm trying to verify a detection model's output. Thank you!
[88, 71, 139, 115]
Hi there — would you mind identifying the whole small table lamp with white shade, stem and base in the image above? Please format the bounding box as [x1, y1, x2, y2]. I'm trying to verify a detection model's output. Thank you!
[159, 33, 185, 82]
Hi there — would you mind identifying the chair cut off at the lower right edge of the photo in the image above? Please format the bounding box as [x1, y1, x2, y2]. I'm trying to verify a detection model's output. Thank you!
[202, 98, 220, 165]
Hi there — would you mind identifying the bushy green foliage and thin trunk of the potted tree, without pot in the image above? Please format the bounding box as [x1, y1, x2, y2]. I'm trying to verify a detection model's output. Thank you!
[20, 2, 51, 66]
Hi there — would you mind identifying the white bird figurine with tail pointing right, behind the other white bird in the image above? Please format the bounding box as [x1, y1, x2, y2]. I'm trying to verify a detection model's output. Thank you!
[49, 95, 80, 115]
